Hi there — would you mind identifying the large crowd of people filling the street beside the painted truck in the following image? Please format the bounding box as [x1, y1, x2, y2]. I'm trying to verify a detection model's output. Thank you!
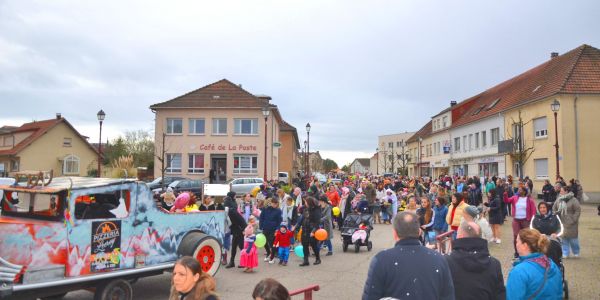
[162, 172, 583, 299]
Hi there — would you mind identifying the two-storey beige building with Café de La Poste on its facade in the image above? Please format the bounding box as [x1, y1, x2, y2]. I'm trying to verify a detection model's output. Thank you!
[150, 79, 294, 182]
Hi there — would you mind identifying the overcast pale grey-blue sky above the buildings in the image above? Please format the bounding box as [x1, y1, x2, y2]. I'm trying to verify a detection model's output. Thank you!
[0, 0, 600, 165]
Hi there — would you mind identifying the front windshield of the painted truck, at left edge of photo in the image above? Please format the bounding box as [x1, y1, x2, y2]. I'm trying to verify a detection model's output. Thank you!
[2, 191, 64, 220]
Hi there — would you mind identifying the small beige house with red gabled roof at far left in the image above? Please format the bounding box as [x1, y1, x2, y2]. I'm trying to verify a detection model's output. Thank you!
[0, 115, 98, 176]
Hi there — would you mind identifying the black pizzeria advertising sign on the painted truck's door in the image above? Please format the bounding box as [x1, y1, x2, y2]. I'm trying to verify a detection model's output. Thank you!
[90, 221, 121, 272]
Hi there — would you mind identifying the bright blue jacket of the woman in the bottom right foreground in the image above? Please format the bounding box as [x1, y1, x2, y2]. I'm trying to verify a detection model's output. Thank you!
[506, 253, 563, 300]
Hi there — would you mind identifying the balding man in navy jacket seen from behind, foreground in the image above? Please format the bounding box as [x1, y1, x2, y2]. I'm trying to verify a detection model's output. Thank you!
[362, 212, 454, 300]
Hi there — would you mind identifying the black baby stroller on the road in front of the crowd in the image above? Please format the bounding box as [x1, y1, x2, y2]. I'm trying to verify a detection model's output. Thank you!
[341, 214, 373, 253]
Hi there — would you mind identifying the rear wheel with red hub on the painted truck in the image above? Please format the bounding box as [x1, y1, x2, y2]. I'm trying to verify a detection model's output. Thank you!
[177, 231, 222, 276]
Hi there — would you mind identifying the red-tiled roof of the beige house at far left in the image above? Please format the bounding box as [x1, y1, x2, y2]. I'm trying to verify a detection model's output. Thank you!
[0, 118, 98, 155]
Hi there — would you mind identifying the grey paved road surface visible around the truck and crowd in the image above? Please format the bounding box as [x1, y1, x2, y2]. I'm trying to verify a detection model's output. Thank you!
[65, 205, 600, 300]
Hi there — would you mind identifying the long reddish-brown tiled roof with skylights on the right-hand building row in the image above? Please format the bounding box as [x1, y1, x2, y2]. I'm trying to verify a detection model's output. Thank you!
[452, 45, 600, 127]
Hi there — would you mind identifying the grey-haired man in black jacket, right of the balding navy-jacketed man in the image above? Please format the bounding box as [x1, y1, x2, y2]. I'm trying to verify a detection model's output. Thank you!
[446, 222, 506, 300]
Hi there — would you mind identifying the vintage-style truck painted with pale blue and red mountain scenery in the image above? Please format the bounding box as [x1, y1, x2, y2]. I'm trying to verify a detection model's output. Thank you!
[0, 177, 225, 300]
